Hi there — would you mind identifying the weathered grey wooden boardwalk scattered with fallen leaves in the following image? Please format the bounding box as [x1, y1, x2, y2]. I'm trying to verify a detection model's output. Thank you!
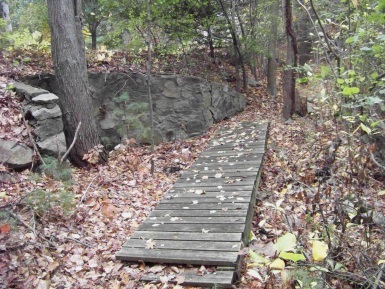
[116, 123, 268, 288]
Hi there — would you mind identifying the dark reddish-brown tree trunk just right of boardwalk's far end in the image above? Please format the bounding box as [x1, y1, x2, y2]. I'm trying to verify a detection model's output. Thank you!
[282, 0, 298, 119]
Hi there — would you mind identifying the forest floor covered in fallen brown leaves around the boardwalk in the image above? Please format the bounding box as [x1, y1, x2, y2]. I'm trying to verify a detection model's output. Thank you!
[0, 48, 385, 289]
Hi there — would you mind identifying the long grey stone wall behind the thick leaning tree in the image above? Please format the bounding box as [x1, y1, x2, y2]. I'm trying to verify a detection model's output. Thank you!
[21, 73, 246, 148]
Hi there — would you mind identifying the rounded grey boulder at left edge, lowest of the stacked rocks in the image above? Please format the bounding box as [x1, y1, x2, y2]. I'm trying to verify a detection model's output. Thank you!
[0, 140, 33, 170]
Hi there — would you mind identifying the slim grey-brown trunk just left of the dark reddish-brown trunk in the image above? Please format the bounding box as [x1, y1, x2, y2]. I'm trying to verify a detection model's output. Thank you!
[267, 0, 279, 98]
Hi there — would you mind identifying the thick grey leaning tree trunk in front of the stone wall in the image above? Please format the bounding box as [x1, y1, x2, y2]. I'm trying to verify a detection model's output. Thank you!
[47, 0, 106, 167]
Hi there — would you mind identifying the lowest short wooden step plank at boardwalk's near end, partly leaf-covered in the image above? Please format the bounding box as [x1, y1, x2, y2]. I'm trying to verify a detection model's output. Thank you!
[140, 271, 234, 288]
